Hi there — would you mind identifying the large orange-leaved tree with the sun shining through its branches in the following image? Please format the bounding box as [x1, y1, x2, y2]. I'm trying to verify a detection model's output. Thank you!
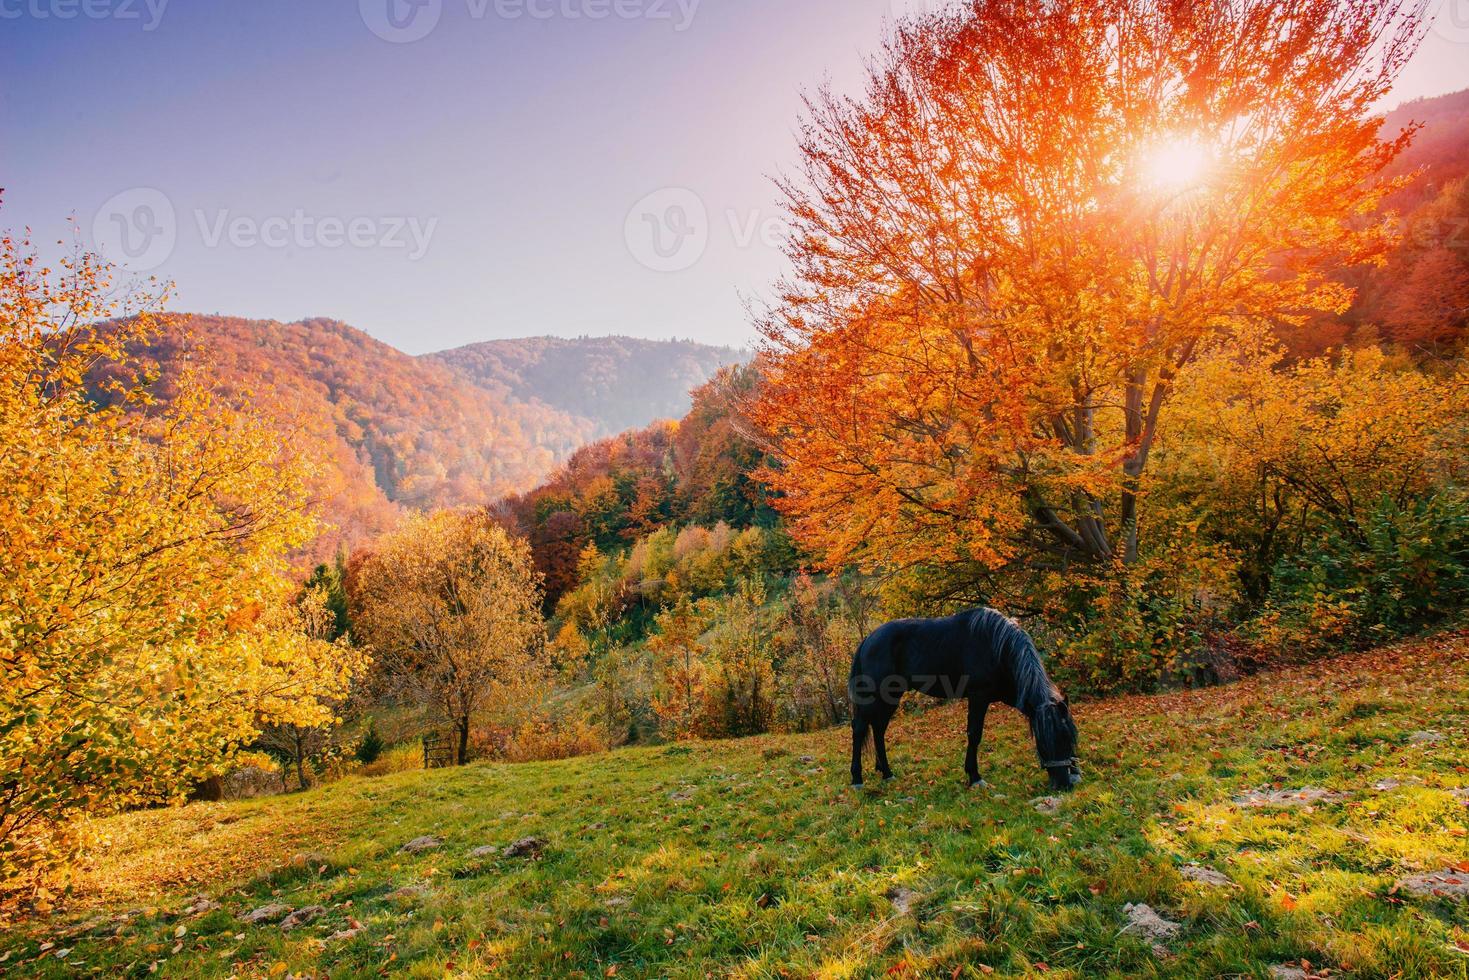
[752, 0, 1422, 594]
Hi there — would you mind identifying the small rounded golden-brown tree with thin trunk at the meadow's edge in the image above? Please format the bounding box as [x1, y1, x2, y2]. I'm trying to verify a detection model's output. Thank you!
[353, 511, 545, 765]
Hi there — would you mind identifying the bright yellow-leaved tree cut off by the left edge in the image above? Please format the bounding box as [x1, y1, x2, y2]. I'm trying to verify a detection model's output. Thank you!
[0, 226, 360, 902]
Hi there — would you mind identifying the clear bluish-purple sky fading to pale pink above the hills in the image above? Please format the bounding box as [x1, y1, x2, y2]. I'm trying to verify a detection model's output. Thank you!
[0, 0, 1469, 353]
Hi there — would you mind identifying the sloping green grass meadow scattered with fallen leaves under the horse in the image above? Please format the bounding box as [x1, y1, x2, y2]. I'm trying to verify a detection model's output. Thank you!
[0, 638, 1469, 977]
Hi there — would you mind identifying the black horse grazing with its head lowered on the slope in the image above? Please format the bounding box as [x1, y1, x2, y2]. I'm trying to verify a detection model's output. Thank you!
[848, 608, 1081, 792]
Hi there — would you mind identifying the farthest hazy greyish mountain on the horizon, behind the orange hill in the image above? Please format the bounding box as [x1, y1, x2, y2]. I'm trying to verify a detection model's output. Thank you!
[427, 336, 749, 438]
